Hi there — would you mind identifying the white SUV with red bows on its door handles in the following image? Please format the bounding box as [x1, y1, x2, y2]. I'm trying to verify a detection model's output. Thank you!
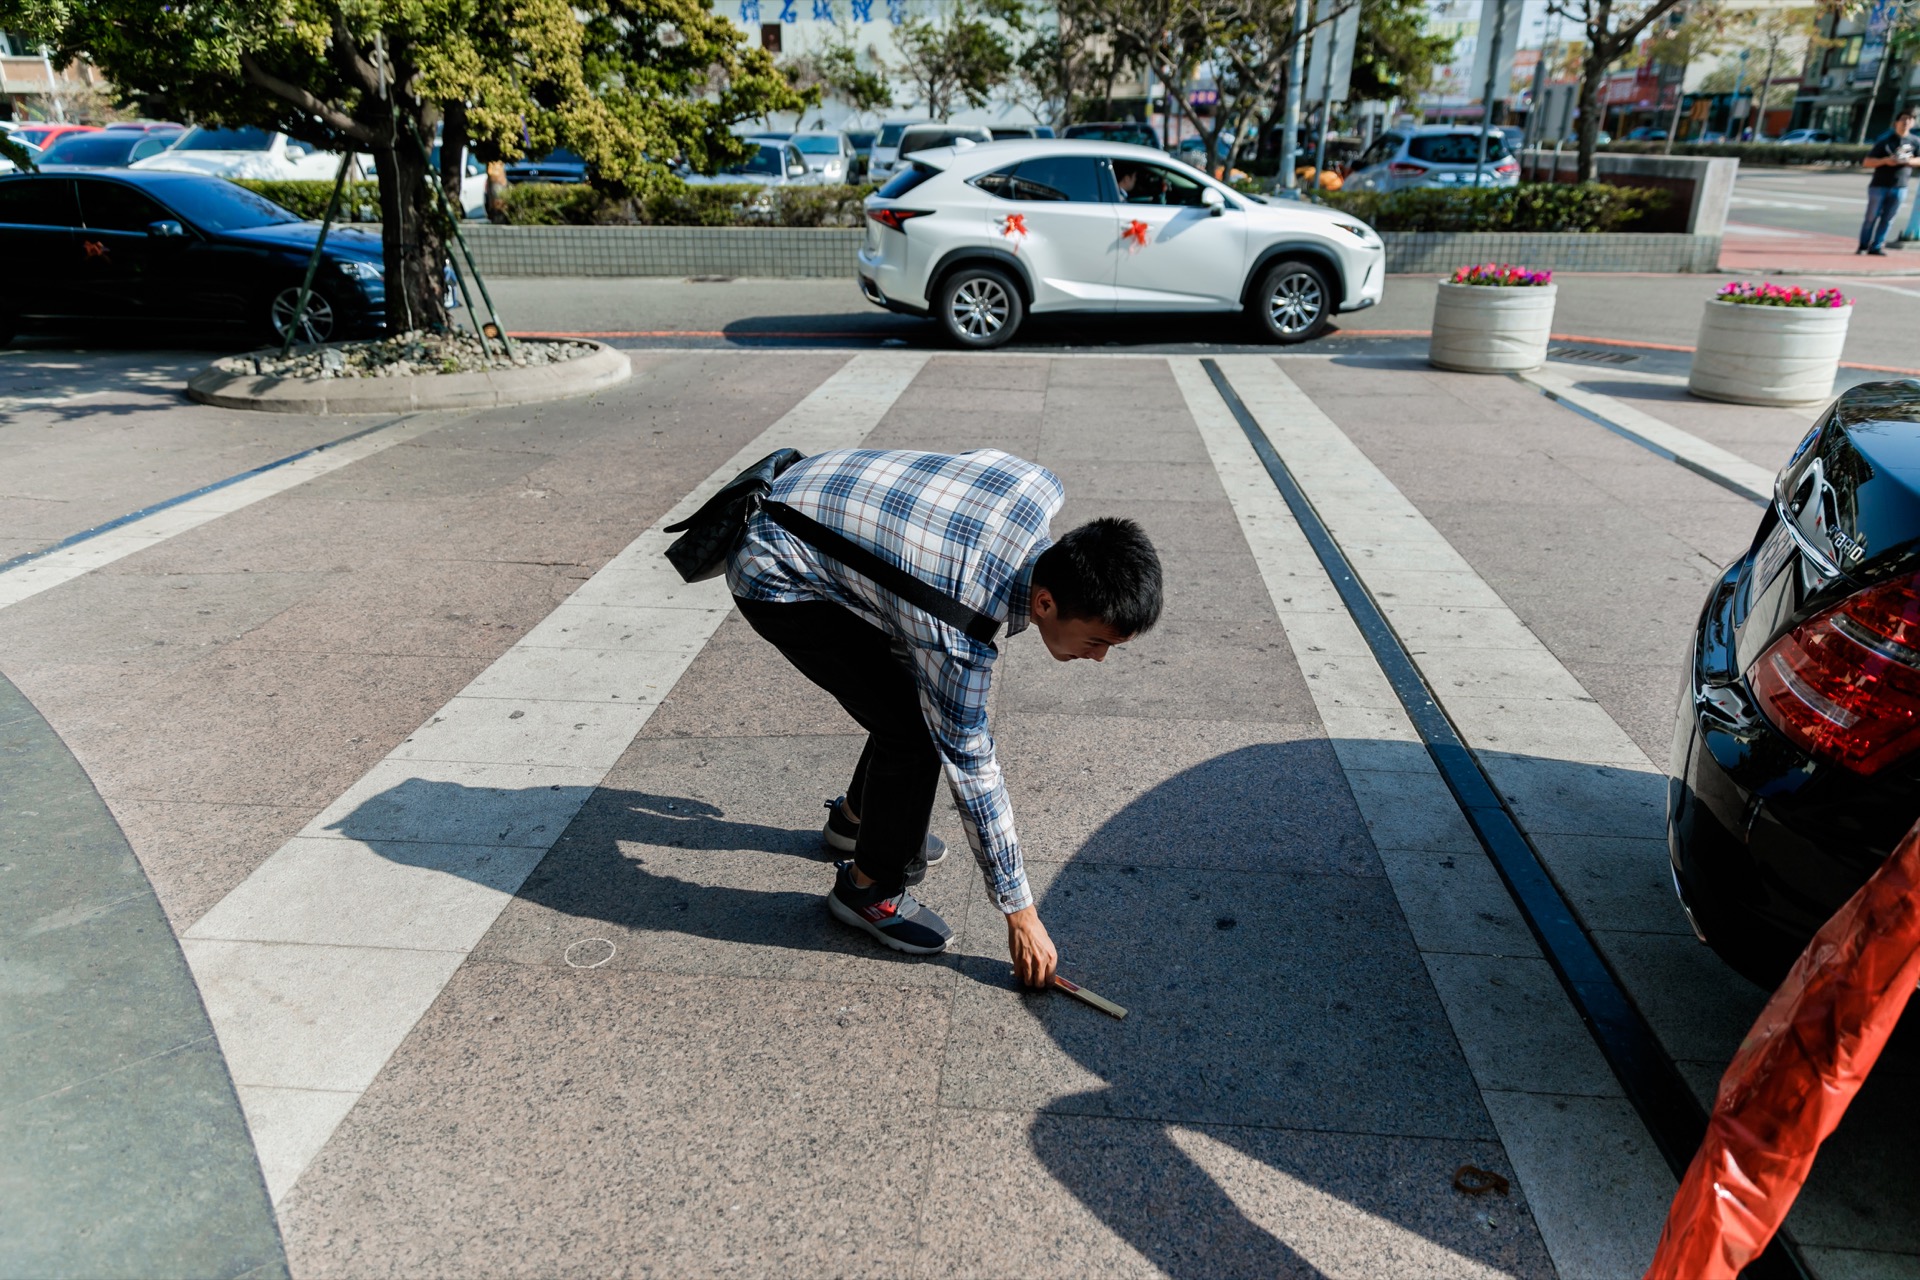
[860, 138, 1386, 349]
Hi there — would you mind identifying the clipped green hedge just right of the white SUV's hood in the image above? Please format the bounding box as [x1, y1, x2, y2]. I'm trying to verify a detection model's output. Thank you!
[1319, 182, 1672, 232]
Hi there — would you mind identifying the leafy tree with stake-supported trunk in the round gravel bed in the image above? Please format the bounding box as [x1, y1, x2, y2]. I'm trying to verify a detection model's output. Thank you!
[0, 0, 801, 332]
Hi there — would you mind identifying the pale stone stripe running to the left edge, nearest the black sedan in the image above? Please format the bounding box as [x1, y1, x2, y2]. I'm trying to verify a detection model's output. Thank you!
[0, 416, 451, 608]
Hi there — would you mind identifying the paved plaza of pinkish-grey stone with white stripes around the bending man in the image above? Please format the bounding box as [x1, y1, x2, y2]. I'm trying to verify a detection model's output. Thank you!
[11, 280, 1920, 1280]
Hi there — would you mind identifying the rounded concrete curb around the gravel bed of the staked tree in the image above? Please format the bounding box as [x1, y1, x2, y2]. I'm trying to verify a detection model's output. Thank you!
[186, 342, 634, 413]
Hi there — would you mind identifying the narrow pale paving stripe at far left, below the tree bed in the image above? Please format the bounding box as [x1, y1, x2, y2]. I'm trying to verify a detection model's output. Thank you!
[0, 415, 447, 608]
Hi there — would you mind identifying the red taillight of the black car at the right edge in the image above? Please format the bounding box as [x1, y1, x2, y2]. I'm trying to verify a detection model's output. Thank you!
[1747, 578, 1920, 775]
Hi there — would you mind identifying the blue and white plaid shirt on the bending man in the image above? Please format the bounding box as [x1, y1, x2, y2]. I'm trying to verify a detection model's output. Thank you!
[728, 449, 1066, 913]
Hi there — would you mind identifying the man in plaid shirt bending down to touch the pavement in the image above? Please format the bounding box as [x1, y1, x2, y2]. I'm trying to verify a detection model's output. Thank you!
[728, 449, 1162, 986]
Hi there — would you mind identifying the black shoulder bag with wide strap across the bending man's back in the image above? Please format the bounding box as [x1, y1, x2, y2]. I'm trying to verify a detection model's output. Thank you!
[666, 449, 1000, 645]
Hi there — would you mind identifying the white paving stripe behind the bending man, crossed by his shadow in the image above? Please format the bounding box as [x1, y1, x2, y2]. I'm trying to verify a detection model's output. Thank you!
[180, 353, 927, 1201]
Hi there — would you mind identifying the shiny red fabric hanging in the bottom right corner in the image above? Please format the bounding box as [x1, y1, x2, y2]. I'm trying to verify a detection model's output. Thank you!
[1647, 823, 1920, 1280]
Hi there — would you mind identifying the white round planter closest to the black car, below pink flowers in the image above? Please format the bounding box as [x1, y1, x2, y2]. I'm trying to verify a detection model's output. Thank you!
[1686, 301, 1853, 405]
